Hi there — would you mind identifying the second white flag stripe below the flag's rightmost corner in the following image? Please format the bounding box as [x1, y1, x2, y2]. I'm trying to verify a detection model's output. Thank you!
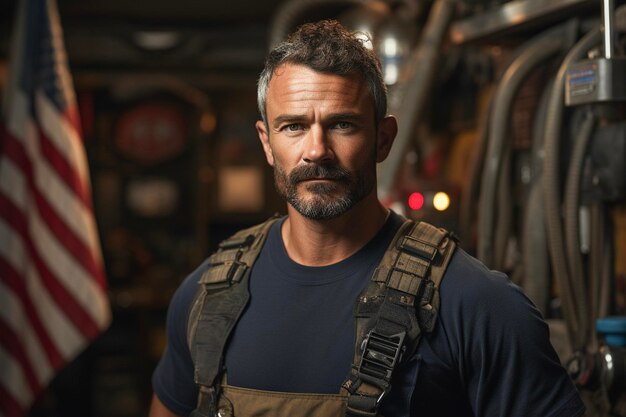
[0, 281, 53, 386]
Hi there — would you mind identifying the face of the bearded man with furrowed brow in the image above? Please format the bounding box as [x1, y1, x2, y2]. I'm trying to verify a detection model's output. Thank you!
[257, 64, 386, 220]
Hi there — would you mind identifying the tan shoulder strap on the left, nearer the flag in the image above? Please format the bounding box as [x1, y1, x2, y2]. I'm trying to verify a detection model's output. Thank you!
[187, 217, 277, 416]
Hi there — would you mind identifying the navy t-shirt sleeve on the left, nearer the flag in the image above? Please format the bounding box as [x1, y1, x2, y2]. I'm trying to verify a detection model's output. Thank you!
[152, 267, 202, 416]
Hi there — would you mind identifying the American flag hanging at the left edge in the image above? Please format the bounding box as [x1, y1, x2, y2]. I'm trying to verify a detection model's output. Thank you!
[0, 0, 110, 417]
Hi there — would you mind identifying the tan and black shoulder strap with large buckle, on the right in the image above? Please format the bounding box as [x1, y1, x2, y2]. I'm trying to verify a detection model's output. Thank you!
[343, 220, 456, 417]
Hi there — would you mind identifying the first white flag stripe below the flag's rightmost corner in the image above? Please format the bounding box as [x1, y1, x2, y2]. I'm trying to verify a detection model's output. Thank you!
[0, 218, 85, 358]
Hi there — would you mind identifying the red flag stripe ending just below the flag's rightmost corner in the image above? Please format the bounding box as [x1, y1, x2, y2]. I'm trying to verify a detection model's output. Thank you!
[0, 194, 100, 340]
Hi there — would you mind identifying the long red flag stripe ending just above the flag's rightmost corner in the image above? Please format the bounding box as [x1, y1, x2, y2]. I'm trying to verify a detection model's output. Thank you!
[4, 128, 106, 290]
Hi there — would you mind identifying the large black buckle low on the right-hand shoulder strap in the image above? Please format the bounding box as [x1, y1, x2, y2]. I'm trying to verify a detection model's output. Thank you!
[359, 330, 406, 386]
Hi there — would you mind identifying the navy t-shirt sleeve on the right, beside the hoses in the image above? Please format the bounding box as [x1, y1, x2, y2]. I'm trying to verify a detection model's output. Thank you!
[441, 251, 584, 417]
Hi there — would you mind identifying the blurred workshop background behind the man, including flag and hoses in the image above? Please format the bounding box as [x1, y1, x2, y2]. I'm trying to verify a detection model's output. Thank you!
[0, 0, 626, 417]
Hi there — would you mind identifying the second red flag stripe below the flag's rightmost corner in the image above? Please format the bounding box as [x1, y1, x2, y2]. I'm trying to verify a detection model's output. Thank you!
[0, 256, 65, 369]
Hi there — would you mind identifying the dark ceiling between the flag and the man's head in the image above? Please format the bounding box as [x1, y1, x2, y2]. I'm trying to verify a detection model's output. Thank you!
[0, 0, 310, 88]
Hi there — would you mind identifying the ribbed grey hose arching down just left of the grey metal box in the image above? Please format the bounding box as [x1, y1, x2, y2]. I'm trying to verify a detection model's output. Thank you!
[543, 29, 601, 351]
